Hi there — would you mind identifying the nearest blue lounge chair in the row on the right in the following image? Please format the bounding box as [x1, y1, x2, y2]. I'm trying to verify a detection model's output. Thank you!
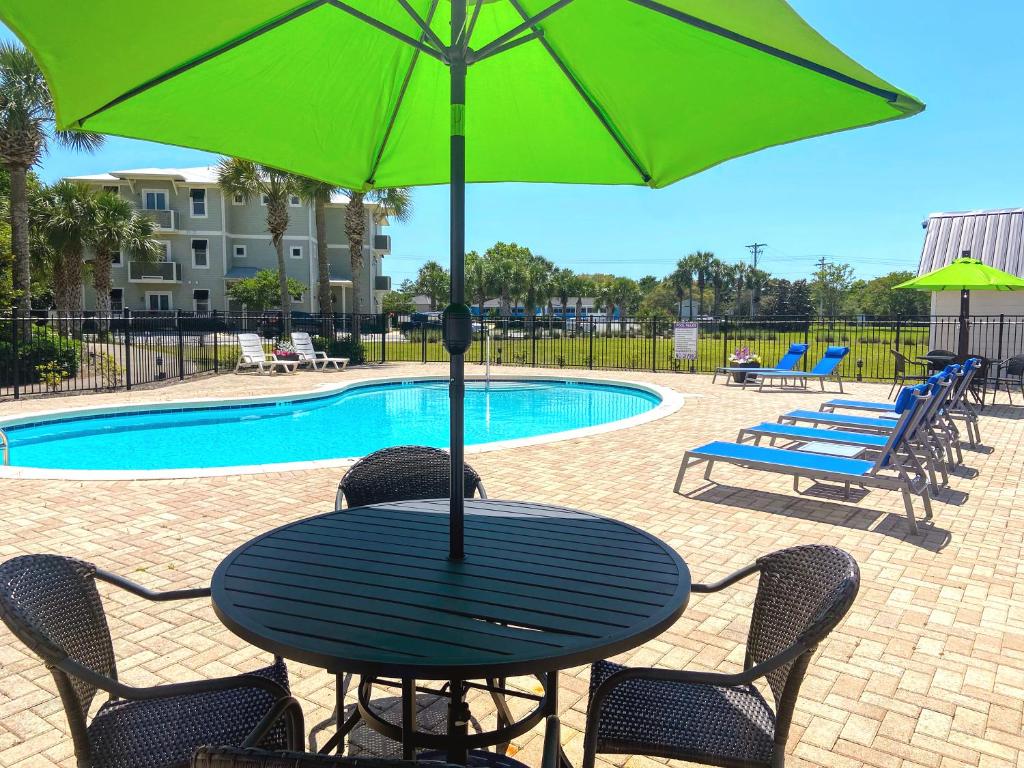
[675, 385, 932, 534]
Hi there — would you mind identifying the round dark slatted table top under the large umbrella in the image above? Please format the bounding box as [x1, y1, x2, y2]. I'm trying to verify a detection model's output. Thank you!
[213, 499, 690, 680]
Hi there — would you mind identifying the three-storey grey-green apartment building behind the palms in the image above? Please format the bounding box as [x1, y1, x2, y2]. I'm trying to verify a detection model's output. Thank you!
[70, 167, 391, 312]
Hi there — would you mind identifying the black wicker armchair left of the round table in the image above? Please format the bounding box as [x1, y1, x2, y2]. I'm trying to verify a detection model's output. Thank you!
[0, 555, 303, 768]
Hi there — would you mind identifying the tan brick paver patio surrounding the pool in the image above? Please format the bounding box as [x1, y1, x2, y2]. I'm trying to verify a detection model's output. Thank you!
[0, 365, 1024, 768]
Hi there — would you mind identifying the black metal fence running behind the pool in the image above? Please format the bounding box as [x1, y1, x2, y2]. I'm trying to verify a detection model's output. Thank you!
[0, 311, 1024, 397]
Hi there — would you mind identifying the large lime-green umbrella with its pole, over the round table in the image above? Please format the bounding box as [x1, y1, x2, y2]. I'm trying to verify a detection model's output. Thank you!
[0, 0, 924, 557]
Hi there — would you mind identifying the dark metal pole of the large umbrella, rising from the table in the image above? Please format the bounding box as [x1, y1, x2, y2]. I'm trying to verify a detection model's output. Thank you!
[449, 0, 466, 560]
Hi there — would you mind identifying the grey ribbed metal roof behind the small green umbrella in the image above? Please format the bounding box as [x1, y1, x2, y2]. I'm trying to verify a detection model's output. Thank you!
[918, 208, 1024, 278]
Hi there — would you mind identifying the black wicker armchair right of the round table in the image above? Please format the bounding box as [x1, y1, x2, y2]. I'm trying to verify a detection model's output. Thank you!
[583, 545, 860, 768]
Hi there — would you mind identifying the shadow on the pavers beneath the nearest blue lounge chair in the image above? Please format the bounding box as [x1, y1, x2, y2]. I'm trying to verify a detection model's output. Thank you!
[683, 483, 951, 552]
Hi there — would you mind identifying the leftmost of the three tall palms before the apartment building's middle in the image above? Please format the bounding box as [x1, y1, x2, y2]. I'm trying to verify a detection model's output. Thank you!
[217, 158, 299, 335]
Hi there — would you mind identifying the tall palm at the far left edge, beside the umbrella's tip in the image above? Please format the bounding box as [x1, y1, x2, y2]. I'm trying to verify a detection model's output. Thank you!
[0, 41, 103, 312]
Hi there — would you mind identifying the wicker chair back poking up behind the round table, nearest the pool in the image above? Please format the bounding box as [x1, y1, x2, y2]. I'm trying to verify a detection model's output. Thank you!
[335, 445, 487, 509]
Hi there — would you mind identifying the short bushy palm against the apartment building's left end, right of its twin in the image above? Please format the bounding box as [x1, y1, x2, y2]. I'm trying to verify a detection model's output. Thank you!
[85, 191, 160, 317]
